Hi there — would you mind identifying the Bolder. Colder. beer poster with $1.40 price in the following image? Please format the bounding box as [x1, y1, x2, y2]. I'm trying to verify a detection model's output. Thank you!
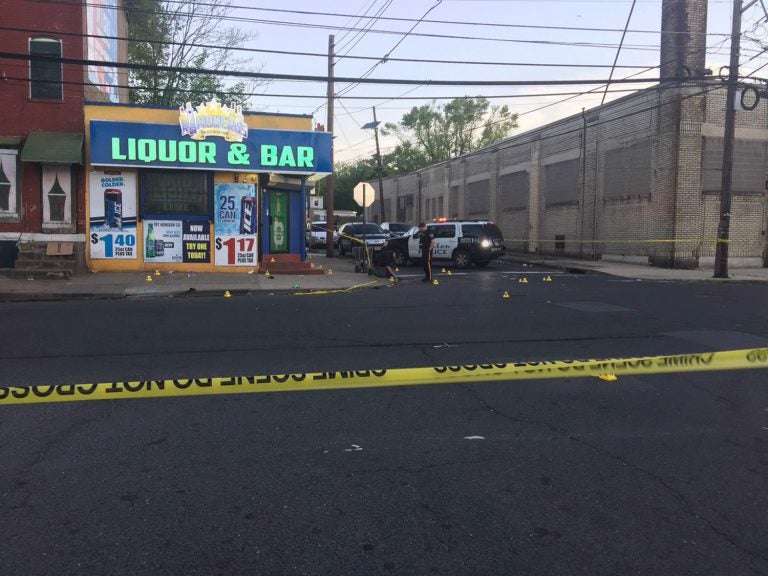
[88, 170, 138, 260]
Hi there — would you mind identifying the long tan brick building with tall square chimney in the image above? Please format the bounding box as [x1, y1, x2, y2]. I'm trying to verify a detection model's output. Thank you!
[367, 0, 768, 268]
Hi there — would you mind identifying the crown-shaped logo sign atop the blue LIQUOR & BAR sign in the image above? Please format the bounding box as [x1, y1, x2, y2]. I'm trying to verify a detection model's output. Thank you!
[179, 98, 248, 142]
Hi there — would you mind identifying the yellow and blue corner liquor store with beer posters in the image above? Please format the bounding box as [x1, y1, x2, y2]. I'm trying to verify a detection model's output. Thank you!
[85, 100, 332, 273]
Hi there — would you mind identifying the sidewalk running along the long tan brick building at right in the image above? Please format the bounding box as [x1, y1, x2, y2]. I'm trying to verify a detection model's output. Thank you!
[504, 253, 768, 282]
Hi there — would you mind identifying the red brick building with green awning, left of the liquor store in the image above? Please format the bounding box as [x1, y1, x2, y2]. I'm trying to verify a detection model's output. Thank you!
[0, 0, 127, 274]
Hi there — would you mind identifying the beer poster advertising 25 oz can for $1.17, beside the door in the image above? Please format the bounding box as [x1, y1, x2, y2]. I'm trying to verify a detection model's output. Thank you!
[214, 184, 258, 266]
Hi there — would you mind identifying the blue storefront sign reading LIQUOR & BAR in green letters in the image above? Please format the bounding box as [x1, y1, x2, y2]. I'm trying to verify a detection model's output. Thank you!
[90, 120, 332, 174]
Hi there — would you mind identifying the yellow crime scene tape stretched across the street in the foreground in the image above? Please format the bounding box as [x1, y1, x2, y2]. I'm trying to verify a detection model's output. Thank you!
[0, 348, 768, 406]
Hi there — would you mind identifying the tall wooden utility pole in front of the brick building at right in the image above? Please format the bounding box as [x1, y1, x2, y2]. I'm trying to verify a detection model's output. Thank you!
[714, 0, 744, 278]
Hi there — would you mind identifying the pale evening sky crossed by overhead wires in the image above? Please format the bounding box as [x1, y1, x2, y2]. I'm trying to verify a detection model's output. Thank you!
[218, 0, 768, 162]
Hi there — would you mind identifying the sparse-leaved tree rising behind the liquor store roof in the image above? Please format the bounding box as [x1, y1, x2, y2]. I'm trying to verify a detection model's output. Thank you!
[125, 0, 260, 106]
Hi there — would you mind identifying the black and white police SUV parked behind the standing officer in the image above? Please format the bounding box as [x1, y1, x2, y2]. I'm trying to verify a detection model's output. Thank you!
[387, 220, 506, 268]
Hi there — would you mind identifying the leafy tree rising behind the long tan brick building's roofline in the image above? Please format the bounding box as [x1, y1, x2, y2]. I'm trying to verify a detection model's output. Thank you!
[384, 97, 517, 168]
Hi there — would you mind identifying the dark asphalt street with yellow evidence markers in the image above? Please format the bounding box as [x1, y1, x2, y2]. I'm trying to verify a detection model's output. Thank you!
[0, 263, 768, 576]
